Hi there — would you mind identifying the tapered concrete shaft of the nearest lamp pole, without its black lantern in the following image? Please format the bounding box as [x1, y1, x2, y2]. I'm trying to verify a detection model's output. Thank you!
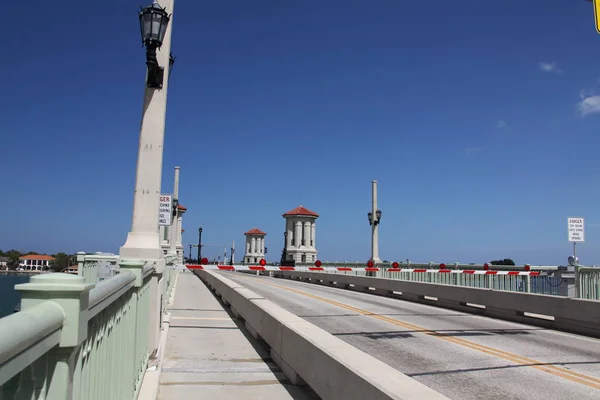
[120, 0, 174, 273]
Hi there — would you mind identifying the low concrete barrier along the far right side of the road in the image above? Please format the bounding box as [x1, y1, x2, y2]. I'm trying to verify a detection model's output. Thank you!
[273, 271, 600, 337]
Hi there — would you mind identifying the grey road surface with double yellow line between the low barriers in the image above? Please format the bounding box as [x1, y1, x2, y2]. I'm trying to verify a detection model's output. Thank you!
[221, 272, 600, 400]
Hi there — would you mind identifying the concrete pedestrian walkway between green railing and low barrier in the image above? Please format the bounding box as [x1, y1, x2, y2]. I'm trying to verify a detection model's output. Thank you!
[158, 269, 318, 400]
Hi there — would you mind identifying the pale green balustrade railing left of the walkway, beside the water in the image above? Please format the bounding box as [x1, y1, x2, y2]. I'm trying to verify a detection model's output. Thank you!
[0, 256, 177, 400]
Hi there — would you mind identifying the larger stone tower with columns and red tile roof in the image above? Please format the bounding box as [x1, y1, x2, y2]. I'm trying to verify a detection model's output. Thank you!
[283, 206, 319, 263]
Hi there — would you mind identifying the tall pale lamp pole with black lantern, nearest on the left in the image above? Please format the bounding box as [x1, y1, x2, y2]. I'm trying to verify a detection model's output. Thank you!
[120, 0, 174, 264]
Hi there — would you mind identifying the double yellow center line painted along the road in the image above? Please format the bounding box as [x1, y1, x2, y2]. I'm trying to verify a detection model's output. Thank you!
[242, 278, 600, 389]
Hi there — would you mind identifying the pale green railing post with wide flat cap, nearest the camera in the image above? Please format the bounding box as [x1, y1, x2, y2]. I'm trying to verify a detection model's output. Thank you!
[15, 273, 95, 400]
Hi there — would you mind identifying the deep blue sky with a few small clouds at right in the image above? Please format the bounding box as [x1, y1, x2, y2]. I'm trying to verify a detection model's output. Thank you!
[0, 0, 600, 264]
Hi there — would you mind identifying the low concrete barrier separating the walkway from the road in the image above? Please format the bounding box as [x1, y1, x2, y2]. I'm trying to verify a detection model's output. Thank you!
[194, 270, 447, 400]
